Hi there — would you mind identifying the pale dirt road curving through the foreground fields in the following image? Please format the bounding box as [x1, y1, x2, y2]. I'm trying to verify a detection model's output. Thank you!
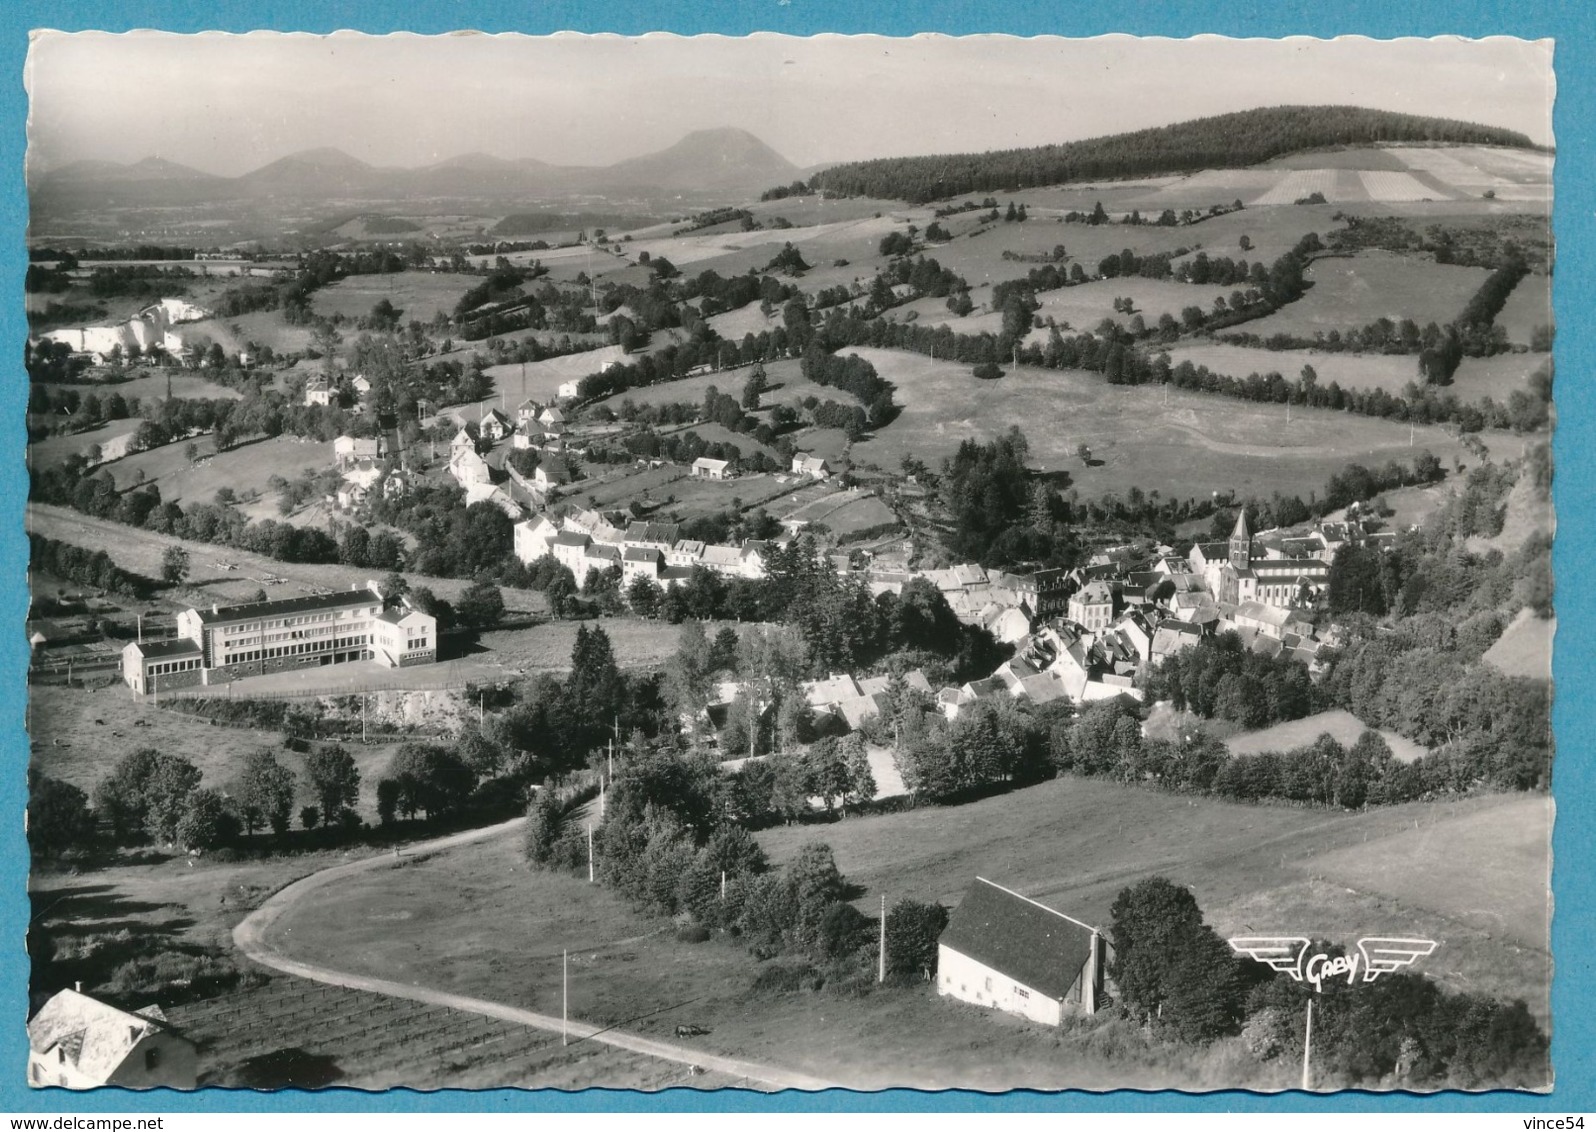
[233, 817, 838, 1090]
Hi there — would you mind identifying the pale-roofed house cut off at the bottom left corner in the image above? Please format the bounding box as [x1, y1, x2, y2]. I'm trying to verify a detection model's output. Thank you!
[27, 990, 200, 1089]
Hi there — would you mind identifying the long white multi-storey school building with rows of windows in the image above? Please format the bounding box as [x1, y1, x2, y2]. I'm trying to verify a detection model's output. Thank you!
[121, 583, 437, 695]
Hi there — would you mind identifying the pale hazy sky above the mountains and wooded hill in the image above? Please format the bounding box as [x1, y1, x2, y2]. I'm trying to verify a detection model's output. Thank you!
[26, 32, 1553, 176]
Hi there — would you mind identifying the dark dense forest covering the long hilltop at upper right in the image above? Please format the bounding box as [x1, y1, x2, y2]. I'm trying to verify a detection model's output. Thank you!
[809, 105, 1532, 204]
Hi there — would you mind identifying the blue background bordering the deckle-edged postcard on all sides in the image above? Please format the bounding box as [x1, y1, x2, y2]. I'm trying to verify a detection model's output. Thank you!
[0, 0, 1596, 1113]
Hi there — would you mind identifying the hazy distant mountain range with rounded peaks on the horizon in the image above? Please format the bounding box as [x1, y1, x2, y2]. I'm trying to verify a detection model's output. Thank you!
[29, 128, 804, 208]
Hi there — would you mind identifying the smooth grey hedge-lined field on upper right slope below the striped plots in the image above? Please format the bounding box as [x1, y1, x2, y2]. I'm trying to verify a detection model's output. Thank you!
[1245, 252, 1491, 338]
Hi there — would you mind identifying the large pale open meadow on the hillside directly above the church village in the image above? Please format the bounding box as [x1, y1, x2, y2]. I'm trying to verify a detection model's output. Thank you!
[851, 348, 1494, 498]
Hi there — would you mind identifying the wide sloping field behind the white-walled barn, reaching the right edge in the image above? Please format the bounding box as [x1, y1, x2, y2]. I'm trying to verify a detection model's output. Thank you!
[760, 779, 1551, 1019]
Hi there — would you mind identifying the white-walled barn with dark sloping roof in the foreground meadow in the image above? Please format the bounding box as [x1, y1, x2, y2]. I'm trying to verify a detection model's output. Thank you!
[937, 877, 1109, 1025]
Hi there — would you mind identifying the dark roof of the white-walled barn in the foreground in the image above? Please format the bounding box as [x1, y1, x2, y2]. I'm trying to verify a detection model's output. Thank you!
[937, 877, 1092, 999]
